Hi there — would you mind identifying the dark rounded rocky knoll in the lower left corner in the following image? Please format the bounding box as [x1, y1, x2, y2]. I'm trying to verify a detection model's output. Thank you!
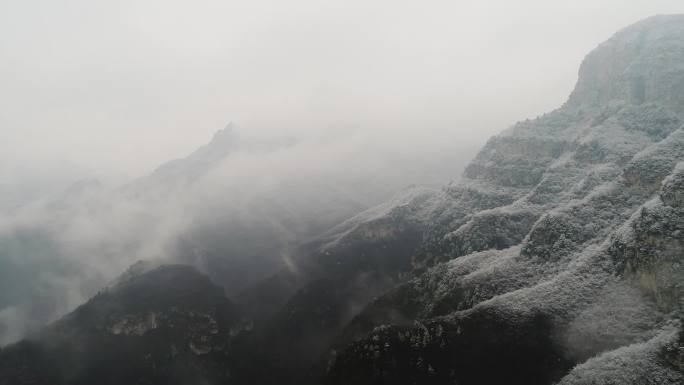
[0, 265, 239, 385]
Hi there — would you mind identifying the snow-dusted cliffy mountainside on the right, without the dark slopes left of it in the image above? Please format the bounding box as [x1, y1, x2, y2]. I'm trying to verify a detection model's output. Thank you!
[327, 16, 684, 384]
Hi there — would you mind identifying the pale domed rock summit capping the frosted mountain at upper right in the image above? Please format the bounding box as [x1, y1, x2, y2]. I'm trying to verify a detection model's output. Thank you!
[568, 14, 684, 116]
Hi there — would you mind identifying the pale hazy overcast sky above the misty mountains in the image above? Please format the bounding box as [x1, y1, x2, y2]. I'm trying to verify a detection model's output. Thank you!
[0, 0, 684, 175]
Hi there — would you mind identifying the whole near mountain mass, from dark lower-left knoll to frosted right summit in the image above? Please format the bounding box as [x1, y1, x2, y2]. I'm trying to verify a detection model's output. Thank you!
[0, 15, 684, 385]
